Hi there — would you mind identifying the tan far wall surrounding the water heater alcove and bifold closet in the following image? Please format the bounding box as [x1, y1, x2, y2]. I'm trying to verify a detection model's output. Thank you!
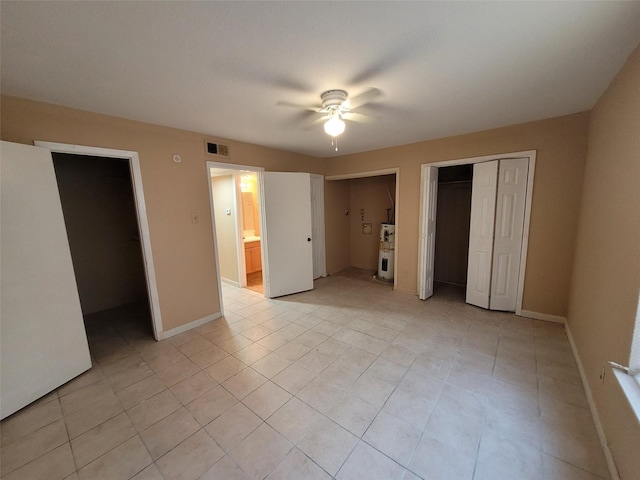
[325, 112, 589, 316]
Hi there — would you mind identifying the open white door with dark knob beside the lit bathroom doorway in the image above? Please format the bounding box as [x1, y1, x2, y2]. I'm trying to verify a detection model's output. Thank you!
[262, 172, 313, 298]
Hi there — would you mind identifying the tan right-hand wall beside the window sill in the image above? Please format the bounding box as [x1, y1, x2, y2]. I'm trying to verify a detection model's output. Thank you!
[568, 48, 640, 479]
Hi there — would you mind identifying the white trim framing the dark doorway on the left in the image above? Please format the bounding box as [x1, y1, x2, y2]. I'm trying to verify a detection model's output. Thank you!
[34, 140, 163, 340]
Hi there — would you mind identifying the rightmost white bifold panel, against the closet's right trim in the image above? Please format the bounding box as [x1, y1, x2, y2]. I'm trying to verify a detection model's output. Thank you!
[489, 158, 529, 312]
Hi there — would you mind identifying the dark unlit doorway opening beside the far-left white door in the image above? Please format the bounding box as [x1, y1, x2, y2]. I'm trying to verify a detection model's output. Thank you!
[52, 152, 154, 344]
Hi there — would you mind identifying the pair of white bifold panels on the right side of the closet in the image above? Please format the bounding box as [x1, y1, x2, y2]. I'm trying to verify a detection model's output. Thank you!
[467, 158, 529, 311]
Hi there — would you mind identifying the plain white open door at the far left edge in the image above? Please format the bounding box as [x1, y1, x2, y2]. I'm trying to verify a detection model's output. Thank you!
[0, 142, 91, 418]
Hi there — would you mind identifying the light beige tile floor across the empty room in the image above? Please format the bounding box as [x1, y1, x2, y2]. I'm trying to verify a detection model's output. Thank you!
[1, 270, 609, 480]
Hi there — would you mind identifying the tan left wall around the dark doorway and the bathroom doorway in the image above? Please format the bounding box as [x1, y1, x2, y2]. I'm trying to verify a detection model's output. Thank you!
[1, 96, 316, 331]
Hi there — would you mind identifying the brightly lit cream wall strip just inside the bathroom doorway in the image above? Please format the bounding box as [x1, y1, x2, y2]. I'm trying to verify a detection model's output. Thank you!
[211, 175, 240, 285]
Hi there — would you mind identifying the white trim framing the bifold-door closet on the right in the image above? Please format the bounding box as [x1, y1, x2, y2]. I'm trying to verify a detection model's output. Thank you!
[417, 150, 536, 321]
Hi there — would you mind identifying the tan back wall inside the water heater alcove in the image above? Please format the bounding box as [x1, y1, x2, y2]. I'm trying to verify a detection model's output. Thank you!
[348, 175, 396, 271]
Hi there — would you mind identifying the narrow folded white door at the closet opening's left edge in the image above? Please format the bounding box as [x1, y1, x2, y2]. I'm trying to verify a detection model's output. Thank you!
[418, 167, 438, 300]
